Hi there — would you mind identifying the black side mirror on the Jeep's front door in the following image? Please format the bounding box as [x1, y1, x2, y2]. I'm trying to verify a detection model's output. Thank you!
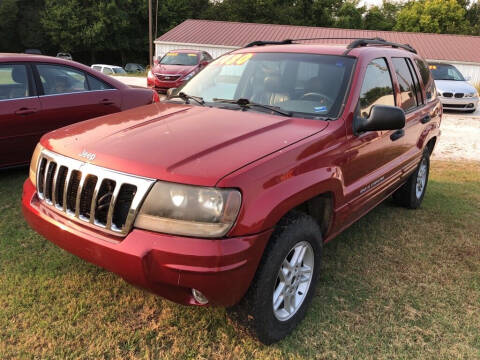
[353, 105, 405, 134]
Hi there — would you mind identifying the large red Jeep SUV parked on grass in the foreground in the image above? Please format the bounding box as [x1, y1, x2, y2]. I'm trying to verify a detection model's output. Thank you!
[23, 39, 442, 343]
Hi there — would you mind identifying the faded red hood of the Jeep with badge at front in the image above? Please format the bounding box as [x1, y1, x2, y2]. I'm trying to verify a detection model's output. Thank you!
[41, 103, 328, 186]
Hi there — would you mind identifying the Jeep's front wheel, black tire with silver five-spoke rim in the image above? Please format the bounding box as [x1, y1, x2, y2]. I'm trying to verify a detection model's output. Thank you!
[232, 213, 322, 345]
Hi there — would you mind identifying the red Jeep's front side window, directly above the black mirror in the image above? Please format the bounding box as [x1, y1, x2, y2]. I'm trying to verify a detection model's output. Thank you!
[360, 58, 395, 118]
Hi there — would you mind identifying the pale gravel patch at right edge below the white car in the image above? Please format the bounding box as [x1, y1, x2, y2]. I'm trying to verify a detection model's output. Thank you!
[432, 113, 480, 161]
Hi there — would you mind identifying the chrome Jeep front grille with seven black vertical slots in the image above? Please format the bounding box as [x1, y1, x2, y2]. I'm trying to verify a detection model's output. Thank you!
[37, 150, 155, 236]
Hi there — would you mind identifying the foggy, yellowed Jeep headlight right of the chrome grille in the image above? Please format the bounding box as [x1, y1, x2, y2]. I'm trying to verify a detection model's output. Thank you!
[135, 181, 242, 238]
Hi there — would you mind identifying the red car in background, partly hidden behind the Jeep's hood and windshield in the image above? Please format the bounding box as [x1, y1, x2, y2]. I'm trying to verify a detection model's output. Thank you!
[147, 50, 212, 92]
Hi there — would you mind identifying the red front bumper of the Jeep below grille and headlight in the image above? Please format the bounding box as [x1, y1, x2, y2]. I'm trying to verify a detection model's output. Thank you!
[22, 179, 271, 306]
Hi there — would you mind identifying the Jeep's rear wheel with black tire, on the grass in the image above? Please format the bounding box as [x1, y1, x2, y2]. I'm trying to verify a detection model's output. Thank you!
[393, 149, 430, 209]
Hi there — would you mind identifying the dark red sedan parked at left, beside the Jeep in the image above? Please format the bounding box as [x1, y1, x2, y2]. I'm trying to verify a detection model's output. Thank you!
[0, 54, 159, 168]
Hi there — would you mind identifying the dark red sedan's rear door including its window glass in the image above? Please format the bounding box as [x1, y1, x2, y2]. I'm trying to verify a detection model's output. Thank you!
[35, 64, 122, 132]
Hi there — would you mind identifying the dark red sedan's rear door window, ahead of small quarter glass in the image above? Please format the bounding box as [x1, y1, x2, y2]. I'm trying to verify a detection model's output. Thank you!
[37, 64, 88, 95]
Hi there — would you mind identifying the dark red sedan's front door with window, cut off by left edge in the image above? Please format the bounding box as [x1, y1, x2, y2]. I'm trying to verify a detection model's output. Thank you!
[0, 63, 42, 167]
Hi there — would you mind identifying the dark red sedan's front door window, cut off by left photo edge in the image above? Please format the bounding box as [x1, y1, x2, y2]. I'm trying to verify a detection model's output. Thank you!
[0, 64, 30, 100]
